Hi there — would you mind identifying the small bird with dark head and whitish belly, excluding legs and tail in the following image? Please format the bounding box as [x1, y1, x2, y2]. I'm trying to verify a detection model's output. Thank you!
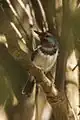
[31, 31, 59, 73]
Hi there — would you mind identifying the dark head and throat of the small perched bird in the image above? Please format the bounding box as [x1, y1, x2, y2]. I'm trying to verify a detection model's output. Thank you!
[35, 31, 59, 55]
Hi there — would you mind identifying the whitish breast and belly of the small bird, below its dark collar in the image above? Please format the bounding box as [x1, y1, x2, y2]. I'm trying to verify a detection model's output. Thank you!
[33, 49, 58, 72]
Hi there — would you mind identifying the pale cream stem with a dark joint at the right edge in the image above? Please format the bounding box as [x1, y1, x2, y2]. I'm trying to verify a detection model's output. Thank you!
[66, 50, 79, 119]
